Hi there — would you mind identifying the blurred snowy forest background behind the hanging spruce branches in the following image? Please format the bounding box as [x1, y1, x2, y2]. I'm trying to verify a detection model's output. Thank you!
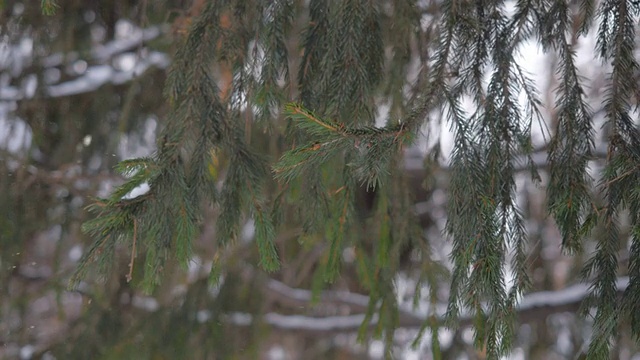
[0, 0, 640, 360]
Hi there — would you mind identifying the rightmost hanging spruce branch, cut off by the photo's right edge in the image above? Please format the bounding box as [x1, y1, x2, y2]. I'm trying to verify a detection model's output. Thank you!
[583, 0, 640, 359]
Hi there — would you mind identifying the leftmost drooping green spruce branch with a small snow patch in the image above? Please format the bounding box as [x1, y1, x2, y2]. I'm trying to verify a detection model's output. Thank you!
[73, 1, 277, 291]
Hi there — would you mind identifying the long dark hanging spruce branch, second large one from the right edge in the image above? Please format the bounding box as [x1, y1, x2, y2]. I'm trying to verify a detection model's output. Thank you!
[442, 1, 541, 352]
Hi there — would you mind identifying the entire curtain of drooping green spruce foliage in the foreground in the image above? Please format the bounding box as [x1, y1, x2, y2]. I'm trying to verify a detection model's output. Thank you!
[26, 0, 640, 359]
